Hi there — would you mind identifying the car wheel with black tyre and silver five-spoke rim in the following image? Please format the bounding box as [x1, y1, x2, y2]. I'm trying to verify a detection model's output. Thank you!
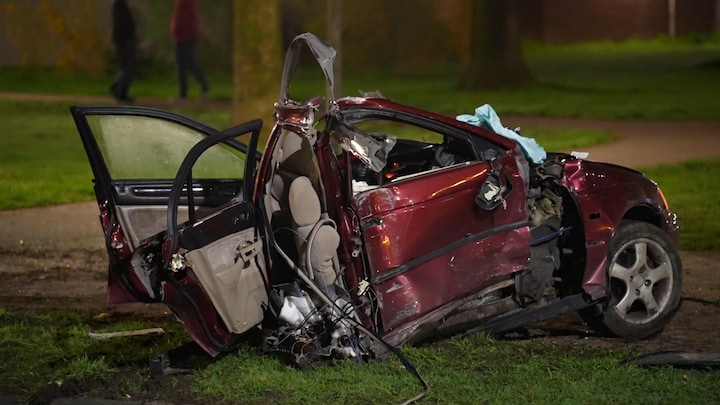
[581, 221, 682, 340]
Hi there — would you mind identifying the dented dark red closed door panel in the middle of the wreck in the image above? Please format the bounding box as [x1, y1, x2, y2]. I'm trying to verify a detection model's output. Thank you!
[355, 152, 530, 332]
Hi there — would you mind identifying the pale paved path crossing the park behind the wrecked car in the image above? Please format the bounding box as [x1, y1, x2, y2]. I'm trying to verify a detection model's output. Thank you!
[0, 92, 720, 250]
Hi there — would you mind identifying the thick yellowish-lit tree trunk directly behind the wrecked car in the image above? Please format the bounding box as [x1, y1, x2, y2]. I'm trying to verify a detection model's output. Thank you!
[232, 0, 283, 129]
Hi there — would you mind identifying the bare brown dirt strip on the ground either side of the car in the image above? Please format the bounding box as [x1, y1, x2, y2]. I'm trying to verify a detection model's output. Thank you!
[0, 245, 720, 352]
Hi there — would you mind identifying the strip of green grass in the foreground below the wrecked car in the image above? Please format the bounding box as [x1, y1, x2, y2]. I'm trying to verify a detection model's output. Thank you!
[0, 308, 720, 404]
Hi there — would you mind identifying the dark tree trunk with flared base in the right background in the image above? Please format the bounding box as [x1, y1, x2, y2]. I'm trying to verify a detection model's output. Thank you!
[460, 0, 531, 90]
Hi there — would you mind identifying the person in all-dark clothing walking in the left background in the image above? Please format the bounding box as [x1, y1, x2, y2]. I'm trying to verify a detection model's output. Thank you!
[110, 0, 135, 102]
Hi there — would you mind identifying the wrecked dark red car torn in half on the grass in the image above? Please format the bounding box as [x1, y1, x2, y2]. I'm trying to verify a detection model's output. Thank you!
[72, 34, 682, 363]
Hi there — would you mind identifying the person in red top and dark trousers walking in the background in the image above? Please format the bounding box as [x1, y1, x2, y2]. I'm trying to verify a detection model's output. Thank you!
[170, 0, 210, 99]
